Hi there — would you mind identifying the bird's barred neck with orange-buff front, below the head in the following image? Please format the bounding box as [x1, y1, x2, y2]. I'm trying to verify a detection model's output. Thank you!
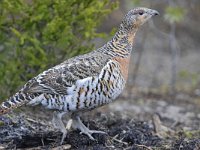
[97, 27, 137, 57]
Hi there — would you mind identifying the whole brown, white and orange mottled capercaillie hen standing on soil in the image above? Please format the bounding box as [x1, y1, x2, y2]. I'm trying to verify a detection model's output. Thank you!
[0, 7, 159, 144]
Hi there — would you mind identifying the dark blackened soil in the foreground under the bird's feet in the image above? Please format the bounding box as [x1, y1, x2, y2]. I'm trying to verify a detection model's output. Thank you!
[0, 113, 200, 150]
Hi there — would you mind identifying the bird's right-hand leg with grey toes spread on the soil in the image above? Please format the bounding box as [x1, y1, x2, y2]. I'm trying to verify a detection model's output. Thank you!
[72, 116, 107, 140]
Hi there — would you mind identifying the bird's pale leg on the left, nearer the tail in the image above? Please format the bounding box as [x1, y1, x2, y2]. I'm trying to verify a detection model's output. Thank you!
[52, 111, 67, 145]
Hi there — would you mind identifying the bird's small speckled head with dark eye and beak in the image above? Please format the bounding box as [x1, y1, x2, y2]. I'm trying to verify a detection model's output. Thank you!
[121, 7, 159, 29]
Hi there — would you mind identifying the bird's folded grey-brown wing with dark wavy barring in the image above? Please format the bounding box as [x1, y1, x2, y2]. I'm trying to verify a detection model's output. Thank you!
[23, 53, 109, 95]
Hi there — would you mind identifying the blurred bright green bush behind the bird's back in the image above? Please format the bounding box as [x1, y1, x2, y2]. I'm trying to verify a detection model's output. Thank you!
[0, 0, 117, 100]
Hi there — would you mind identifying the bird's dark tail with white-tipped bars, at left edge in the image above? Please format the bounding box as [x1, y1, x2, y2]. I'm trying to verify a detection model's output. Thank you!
[0, 92, 29, 115]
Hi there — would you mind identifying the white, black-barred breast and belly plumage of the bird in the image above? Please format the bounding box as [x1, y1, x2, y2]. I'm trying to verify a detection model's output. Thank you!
[68, 61, 125, 110]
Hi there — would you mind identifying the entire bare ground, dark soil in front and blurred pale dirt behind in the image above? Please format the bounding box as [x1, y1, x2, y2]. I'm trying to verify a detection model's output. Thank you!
[0, 91, 200, 150]
